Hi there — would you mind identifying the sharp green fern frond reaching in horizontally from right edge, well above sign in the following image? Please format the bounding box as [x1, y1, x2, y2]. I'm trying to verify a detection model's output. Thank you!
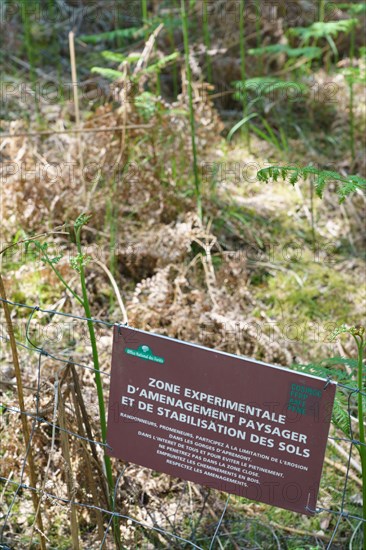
[257, 166, 366, 203]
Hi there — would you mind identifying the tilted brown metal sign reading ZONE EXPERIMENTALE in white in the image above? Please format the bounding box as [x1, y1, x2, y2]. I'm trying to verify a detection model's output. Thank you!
[107, 327, 336, 515]
